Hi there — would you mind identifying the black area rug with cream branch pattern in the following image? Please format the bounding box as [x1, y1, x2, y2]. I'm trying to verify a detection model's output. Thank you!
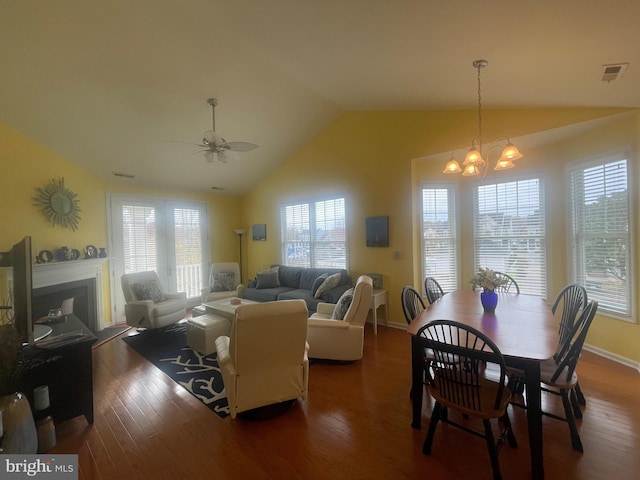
[122, 323, 229, 418]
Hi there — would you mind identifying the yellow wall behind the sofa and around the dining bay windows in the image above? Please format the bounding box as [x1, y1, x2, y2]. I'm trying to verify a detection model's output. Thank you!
[243, 109, 640, 361]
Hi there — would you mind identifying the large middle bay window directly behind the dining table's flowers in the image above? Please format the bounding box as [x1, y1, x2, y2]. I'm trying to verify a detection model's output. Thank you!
[473, 178, 547, 297]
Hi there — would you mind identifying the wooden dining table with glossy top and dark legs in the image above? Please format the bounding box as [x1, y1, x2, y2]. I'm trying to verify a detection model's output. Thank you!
[407, 288, 558, 480]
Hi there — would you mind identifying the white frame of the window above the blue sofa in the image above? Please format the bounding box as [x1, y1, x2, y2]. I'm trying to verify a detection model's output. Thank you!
[280, 195, 349, 270]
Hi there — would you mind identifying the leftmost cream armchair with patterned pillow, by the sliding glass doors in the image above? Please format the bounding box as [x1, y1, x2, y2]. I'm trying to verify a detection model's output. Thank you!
[120, 271, 187, 328]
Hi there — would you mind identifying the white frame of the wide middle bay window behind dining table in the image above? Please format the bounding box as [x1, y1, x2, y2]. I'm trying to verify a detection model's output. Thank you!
[472, 175, 549, 298]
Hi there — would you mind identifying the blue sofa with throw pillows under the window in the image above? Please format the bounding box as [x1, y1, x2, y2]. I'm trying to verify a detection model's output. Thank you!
[244, 264, 352, 314]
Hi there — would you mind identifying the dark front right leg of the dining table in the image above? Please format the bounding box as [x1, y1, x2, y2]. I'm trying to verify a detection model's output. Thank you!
[521, 361, 544, 480]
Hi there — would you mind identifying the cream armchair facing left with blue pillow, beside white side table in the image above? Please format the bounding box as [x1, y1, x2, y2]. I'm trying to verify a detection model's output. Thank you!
[307, 275, 373, 361]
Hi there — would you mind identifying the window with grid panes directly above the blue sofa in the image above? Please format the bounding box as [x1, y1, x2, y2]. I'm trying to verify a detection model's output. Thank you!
[280, 198, 347, 269]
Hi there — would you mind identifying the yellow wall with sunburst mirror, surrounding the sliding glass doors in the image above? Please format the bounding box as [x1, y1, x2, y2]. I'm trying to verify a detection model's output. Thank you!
[0, 122, 241, 324]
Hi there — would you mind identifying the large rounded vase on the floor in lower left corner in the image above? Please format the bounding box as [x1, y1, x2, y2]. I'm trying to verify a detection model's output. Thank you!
[0, 392, 38, 454]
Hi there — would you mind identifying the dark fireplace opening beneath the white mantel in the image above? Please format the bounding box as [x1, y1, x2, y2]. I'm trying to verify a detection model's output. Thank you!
[33, 278, 100, 333]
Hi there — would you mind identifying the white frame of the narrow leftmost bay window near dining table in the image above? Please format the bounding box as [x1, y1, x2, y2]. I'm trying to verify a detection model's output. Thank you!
[418, 183, 460, 293]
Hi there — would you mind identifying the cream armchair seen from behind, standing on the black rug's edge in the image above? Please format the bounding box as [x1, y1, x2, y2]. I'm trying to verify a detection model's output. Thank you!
[216, 300, 309, 418]
